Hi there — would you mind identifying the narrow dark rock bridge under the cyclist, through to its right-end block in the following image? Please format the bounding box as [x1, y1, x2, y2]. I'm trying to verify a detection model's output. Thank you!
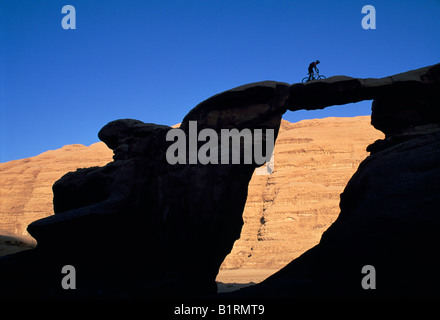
[286, 64, 440, 120]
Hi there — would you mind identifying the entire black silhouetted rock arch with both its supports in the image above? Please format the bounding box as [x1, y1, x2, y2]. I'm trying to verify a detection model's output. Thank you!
[0, 65, 440, 297]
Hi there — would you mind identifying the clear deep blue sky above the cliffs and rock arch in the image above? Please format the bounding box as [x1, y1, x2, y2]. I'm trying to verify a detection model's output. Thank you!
[0, 0, 440, 162]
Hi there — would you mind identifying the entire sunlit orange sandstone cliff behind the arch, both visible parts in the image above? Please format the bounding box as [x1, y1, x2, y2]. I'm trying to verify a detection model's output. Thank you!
[0, 116, 383, 269]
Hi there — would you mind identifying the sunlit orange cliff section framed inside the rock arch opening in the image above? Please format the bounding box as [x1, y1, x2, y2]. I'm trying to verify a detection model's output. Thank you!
[222, 117, 384, 269]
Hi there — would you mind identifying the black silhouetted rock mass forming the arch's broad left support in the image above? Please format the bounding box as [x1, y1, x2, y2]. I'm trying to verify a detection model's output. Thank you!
[0, 81, 288, 297]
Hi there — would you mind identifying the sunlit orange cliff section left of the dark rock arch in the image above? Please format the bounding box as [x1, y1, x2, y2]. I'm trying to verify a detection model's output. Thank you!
[0, 142, 112, 235]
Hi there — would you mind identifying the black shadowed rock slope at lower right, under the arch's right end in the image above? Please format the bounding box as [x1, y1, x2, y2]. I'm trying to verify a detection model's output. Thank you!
[237, 124, 440, 297]
